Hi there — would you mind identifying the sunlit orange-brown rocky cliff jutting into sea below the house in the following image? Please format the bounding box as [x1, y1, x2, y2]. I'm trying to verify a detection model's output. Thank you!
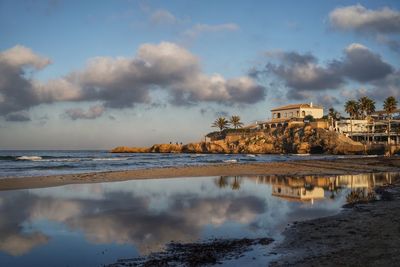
[111, 125, 376, 155]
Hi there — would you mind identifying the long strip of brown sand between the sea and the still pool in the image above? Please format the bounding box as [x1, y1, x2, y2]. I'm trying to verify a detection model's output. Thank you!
[0, 157, 400, 191]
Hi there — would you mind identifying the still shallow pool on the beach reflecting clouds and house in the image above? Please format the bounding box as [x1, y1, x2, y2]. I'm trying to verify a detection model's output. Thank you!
[0, 174, 394, 267]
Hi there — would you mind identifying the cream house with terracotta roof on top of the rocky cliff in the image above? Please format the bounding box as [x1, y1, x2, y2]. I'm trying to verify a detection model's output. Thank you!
[271, 102, 324, 121]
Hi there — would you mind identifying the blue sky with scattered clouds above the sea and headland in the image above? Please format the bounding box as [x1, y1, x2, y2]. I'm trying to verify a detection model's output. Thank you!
[0, 0, 400, 149]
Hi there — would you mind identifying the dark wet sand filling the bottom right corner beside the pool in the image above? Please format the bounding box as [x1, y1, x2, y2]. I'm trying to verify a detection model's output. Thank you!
[271, 181, 400, 267]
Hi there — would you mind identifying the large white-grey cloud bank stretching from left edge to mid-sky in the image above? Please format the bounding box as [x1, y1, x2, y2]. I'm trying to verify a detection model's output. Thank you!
[0, 42, 265, 119]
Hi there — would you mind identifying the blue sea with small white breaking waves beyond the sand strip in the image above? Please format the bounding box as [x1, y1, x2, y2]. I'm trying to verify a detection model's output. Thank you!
[0, 150, 376, 178]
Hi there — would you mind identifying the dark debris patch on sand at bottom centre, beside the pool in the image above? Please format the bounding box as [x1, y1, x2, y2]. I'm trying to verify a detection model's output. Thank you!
[108, 238, 273, 267]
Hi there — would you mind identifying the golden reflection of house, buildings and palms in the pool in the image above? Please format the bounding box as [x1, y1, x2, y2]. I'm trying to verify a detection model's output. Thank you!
[215, 173, 399, 203]
